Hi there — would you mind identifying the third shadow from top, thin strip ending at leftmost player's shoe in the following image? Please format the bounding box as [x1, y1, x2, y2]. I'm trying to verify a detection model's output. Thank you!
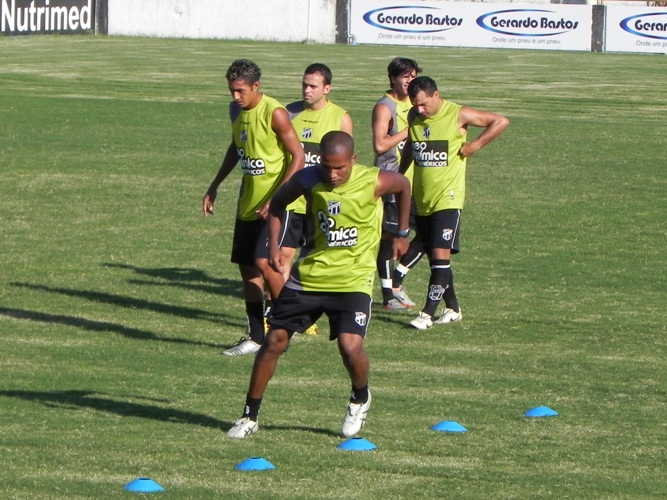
[0, 307, 225, 349]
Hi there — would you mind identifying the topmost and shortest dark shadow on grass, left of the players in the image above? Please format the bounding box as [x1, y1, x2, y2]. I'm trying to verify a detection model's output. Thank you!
[102, 263, 243, 300]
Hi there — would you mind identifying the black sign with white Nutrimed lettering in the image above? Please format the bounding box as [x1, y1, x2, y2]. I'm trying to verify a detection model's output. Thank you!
[0, 0, 95, 35]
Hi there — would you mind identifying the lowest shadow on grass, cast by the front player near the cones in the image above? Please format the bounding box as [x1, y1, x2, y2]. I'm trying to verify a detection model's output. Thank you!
[0, 390, 338, 436]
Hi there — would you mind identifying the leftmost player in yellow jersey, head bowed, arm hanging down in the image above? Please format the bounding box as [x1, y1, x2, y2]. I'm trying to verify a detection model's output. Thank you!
[203, 59, 305, 356]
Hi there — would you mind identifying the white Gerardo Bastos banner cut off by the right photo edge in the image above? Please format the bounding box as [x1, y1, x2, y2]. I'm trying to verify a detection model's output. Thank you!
[605, 5, 667, 54]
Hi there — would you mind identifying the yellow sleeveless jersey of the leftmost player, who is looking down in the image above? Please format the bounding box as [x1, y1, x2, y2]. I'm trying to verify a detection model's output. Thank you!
[229, 95, 289, 220]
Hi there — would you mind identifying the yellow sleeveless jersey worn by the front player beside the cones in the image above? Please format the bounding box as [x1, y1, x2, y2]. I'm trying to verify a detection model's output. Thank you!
[285, 165, 382, 296]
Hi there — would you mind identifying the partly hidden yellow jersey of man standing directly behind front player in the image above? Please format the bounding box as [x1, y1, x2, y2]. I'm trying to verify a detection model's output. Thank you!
[287, 101, 347, 214]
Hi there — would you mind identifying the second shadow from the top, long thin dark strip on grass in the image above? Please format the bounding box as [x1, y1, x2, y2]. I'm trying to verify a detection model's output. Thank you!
[10, 282, 241, 326]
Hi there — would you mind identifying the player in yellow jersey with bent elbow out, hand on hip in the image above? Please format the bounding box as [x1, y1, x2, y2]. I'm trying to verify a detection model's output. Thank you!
[400, 76, 509, 330]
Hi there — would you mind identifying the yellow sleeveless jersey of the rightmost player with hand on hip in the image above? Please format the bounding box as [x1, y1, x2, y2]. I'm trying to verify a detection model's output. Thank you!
[409, 101, 466, 215]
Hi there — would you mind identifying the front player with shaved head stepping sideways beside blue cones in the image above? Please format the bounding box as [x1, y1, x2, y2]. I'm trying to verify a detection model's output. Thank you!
[227, 131, 410, 439]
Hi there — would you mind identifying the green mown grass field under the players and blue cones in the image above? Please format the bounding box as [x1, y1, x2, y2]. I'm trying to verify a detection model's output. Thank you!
[0, 36, 667, 499]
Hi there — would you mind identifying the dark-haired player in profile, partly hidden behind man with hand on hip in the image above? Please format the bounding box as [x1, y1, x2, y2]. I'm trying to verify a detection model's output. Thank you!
[372, 57, 424, 311]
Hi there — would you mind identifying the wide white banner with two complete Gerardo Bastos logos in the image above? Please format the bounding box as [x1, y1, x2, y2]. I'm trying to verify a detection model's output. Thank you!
[350, 0, 592, 51]
